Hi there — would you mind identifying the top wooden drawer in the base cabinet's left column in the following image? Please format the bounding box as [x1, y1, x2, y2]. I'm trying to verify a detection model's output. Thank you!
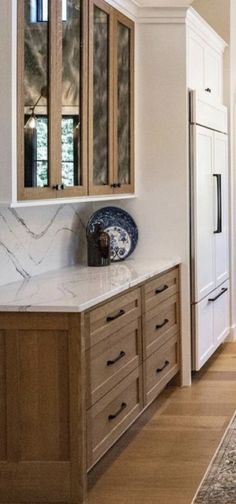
[86, 289, 141, 348]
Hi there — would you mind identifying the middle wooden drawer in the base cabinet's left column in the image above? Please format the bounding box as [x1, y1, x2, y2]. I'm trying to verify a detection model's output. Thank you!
[86, 318, 141, 407]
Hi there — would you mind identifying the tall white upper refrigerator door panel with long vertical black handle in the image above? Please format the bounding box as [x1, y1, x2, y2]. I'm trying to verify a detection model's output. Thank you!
[192, 125, 229, 302]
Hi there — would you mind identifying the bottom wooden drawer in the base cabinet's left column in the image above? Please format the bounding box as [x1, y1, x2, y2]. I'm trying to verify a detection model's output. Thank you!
[87, 367, 143, 468]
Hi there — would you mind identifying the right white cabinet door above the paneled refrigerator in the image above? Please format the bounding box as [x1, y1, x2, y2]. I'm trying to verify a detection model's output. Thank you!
[204, 46, 223, 101]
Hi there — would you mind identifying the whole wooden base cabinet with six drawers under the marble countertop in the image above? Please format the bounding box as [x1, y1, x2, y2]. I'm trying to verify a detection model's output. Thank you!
[0, 268, 179, 504]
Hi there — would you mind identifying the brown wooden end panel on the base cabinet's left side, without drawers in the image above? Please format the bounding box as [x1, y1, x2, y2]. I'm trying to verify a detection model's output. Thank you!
[0, 313, 86, 503]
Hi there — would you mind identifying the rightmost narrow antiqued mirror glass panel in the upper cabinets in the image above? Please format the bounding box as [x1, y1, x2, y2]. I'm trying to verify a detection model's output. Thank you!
[117, 23, 131, 184]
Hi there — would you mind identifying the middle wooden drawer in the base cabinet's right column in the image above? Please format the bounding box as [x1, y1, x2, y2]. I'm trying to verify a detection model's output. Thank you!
[144, 294, 179, 357]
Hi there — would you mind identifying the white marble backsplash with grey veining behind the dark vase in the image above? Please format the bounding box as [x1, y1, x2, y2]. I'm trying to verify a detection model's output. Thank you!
[0, 203, 93, 285]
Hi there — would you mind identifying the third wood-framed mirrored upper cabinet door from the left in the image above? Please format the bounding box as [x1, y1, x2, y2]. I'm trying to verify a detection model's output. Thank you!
[89, 0, 113, 194]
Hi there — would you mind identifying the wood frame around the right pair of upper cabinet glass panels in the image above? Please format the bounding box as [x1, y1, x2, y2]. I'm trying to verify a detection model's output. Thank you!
[88, 0, 134, 195]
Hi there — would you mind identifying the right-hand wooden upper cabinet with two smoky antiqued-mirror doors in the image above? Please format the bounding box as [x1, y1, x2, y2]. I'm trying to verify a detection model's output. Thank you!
[89, 0, 134, 194]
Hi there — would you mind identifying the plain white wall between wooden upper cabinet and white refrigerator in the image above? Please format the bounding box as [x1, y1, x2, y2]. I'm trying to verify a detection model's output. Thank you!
[125, 18, 190, 385]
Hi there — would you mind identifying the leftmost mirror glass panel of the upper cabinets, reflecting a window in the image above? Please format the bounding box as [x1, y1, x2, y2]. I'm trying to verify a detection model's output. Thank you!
[24, 0, 49, 187]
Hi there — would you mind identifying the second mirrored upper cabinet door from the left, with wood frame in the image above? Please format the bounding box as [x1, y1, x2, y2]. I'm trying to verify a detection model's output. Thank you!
[59, 0, 87, 197]
